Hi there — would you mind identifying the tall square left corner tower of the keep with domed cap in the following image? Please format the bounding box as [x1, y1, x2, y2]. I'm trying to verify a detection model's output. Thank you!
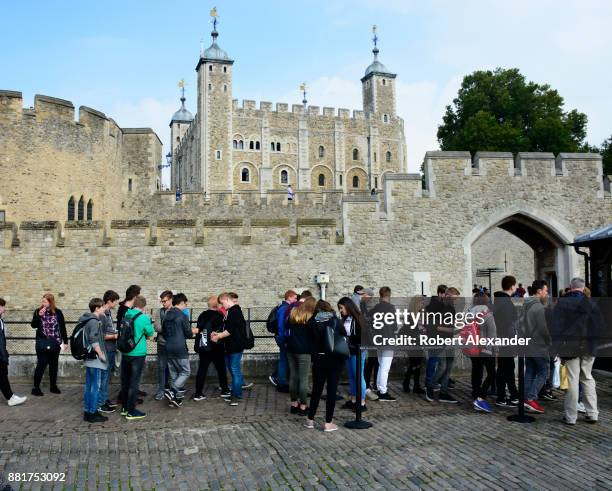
[193, 10, 234, 194]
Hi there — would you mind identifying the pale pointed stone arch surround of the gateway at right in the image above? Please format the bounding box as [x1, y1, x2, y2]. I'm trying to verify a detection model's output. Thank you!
[463, 205, 577, 294]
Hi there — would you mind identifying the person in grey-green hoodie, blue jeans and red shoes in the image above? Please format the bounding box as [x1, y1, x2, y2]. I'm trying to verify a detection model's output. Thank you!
[524, 280, 551, 413]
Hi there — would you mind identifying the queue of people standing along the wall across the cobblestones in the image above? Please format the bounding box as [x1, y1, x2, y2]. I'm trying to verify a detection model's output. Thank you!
[0, 276, 598, 432]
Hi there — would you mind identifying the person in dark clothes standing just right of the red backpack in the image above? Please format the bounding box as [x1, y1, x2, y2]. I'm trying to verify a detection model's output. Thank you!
[493, 276, 518, 407]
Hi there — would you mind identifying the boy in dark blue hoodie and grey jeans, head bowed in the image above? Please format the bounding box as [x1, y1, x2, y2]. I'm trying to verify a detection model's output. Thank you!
[162, 293, 198, 407]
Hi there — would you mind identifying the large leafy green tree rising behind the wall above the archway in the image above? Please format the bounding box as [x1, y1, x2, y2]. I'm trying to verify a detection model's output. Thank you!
[438, 68, 587, 154]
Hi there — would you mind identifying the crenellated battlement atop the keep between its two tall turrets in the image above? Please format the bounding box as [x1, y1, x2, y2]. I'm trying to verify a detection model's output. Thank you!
[232, 99, 392, 121]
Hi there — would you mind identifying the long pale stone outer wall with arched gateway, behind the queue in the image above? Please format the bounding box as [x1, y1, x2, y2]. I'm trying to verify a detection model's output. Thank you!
[0, 152, 612, 309]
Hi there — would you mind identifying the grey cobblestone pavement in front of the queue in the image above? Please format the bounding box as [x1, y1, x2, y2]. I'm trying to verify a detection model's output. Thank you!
[0, 378, 612, 490]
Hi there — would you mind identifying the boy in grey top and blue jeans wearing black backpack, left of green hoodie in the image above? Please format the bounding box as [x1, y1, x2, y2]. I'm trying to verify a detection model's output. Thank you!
[79, 298, 108, 423]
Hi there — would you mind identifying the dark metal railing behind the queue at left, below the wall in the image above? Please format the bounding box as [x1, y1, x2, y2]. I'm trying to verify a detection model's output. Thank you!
[2, 307, 278, 356]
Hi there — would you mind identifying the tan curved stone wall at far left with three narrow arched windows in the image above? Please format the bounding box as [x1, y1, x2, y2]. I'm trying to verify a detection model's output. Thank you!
[0, 91, 161, 222]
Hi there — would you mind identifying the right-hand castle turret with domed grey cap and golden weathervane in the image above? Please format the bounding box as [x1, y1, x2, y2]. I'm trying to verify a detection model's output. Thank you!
[361, 26, 397, 123]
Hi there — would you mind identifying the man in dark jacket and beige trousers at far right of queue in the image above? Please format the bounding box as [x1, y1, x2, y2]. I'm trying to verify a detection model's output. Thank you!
[551, 278, 602, 425]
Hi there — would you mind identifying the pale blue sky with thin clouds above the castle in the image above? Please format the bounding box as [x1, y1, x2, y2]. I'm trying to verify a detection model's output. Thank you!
[0, 0, 612, 184]
